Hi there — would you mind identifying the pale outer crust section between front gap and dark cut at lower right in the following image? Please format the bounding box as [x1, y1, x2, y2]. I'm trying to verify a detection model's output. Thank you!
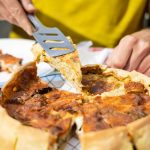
[79, 127, 133, 150]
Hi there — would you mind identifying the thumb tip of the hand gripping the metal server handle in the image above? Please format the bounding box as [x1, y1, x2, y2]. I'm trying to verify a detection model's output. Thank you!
[21, 0, 35, 13]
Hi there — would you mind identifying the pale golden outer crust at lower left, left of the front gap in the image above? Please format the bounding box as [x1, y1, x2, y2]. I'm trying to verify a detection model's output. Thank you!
[0, 107, 54, 150]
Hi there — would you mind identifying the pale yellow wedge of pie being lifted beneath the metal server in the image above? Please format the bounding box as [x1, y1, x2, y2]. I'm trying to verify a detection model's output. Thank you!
[32, 38, 82, 92]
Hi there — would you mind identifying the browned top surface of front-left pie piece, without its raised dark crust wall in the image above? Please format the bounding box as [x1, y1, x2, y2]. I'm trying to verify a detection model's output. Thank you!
[3, 84, 81, 135]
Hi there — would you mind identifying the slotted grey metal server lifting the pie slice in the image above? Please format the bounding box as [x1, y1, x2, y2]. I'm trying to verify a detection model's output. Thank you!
[27, 14, 75, 57]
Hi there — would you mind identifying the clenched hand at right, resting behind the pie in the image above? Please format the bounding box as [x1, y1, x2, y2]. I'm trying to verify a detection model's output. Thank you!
[106, 29, 150, 76]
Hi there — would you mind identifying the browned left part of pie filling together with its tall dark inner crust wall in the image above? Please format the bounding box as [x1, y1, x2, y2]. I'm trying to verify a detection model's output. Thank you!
[1, 63, 82, 136]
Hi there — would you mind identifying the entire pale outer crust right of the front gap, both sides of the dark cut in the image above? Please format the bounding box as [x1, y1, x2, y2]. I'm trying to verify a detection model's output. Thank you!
[77, 115, 150, 150]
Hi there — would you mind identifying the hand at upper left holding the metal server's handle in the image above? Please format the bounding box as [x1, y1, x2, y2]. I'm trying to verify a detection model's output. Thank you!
[0, 0, 35, 35]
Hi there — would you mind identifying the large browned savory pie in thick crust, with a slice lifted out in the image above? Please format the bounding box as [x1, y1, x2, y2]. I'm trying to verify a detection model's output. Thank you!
[0, 62, 150, 150]
